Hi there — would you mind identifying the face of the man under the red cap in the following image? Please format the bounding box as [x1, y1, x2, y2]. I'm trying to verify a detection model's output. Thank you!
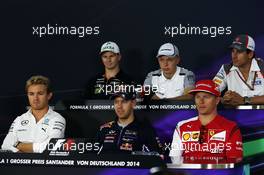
[194, 92, 220, 115]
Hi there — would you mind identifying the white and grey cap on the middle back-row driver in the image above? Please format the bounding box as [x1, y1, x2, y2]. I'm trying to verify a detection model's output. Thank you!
[157, 43, 179, 58]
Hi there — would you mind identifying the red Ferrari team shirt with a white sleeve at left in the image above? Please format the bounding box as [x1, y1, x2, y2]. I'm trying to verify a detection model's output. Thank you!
[170, 115, 243, 163]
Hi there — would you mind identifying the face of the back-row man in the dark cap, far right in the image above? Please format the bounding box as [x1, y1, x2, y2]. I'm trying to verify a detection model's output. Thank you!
[231, 48, 253, 67]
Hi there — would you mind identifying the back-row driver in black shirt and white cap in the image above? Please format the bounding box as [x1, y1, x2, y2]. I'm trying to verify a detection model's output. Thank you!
[84, 41, 134, 99]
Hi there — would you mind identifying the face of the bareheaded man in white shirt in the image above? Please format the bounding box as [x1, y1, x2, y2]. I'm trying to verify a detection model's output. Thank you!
[27, 84, 52, 110]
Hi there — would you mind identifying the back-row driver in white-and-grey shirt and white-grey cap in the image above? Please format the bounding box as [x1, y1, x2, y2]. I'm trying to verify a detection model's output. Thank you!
[144, 43, 195, 100]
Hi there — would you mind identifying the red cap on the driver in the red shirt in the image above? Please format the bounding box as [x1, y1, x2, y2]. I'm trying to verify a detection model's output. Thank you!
[189, 80, 221, 97]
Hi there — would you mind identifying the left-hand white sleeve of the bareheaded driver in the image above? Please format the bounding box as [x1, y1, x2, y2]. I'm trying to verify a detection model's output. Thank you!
[2, 117, 19, 152]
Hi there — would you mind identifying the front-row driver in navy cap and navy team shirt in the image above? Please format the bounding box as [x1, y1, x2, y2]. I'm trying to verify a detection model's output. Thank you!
[97, 92, 162, 153]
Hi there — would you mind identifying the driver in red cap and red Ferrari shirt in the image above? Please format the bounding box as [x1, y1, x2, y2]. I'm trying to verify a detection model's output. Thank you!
[170, 80, 243, 164]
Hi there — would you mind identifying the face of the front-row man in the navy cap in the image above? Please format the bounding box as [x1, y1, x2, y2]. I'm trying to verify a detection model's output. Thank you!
[114, 97, 136, 119]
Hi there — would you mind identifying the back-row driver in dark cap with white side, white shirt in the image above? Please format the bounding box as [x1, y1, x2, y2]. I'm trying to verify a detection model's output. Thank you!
[214, 35, 264, 106]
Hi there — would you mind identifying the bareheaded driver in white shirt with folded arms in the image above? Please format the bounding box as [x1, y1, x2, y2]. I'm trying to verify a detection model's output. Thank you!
[2, 76, 66, 153]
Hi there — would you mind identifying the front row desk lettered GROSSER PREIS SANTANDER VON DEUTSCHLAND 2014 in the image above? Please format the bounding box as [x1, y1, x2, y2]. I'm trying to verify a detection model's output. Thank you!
[0, 152, 249, 175]
